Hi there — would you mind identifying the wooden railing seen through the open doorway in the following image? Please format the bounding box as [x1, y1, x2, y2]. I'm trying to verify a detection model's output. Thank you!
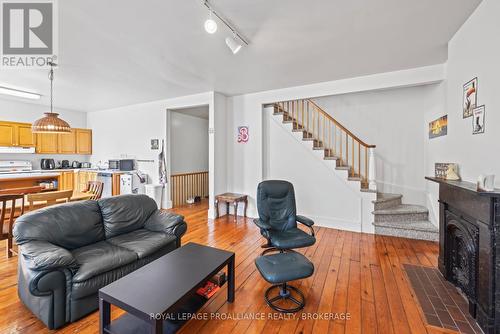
[170, 171, 208, 207]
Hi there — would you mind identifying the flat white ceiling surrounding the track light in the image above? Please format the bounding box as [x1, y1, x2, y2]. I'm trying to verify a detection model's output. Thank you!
[0, 0, 481, 111]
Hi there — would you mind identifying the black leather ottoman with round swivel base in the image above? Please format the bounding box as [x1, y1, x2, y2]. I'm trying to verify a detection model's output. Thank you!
[255, 252, 314, 313]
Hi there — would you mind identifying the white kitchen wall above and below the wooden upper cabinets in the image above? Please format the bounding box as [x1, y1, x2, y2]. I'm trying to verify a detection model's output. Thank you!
[0, 98, 89, 169]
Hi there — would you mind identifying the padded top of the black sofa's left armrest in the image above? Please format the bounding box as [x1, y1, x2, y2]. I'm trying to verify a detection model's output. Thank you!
[19, 240, 78, 271]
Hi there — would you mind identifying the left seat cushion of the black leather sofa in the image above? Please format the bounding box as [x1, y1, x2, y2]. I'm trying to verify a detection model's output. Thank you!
[72, 241, 137, 282]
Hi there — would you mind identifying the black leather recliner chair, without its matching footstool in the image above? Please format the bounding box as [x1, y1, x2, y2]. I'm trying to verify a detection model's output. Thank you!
[254, 180, 316, 250]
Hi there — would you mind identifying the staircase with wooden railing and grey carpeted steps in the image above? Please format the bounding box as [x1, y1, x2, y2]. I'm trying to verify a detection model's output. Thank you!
[271, 99, 438, 241]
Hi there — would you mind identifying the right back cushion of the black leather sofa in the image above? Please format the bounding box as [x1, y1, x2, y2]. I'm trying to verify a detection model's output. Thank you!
[97, 195, 158, 239]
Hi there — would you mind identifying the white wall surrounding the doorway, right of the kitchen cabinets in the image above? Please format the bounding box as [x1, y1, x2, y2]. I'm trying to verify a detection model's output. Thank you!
[87, 92, 226, 214]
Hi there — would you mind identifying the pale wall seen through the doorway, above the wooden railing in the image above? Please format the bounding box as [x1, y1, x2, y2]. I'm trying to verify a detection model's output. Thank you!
[170, 110, 208, 174]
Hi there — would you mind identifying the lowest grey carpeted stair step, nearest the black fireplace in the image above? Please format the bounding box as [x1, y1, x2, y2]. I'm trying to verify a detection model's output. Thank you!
[373, 220, 439, 241]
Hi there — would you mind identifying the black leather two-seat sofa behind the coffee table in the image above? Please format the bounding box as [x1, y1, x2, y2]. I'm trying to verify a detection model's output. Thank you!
[14, 195, 187, 329]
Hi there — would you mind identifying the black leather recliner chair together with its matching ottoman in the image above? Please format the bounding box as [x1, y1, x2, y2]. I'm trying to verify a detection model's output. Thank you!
[254, 180, 316, 313]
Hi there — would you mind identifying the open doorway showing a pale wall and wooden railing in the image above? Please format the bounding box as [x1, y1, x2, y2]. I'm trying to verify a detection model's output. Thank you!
[168, 105, 209, 207]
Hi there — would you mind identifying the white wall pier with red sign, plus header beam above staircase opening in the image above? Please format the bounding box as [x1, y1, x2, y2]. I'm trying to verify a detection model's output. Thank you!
[227, 65, 444, 217]
